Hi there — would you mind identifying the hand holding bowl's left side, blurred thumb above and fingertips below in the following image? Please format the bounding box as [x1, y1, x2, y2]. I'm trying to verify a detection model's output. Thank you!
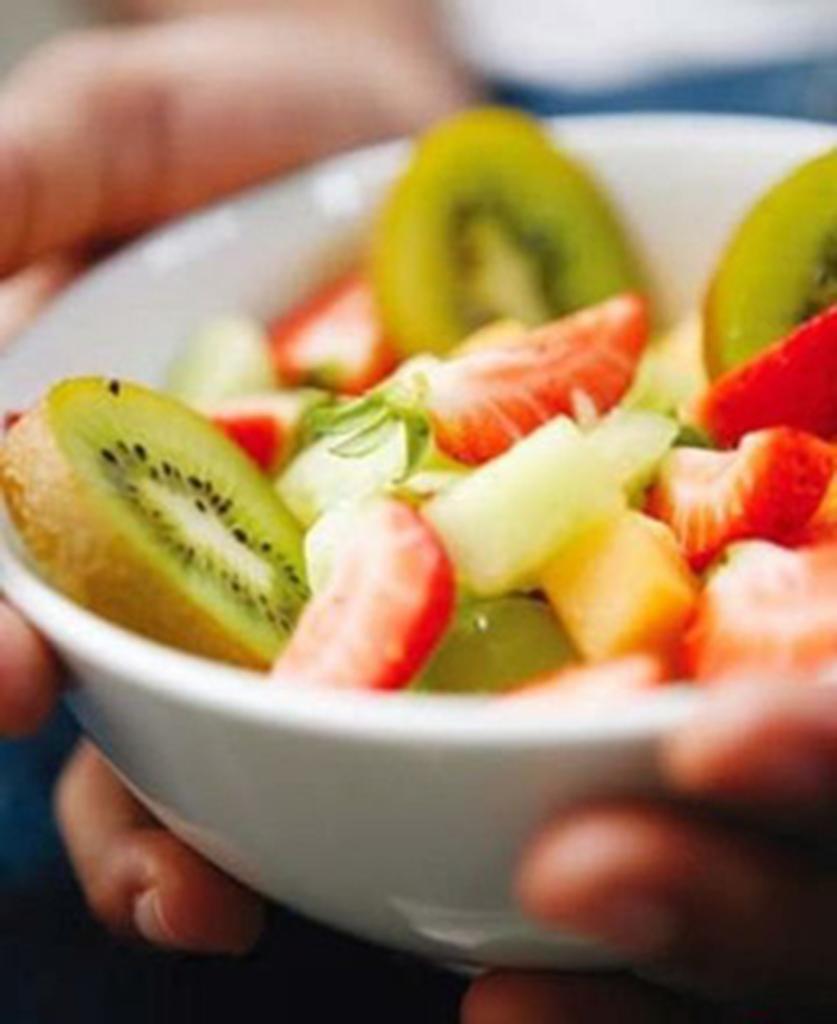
[0, 8, 461, 953]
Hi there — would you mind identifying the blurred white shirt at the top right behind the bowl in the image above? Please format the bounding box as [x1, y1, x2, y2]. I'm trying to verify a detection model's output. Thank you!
[440, 0, 837, 89]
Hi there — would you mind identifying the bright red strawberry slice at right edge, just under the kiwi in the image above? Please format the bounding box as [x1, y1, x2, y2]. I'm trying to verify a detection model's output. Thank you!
[697, 306, 837, 445]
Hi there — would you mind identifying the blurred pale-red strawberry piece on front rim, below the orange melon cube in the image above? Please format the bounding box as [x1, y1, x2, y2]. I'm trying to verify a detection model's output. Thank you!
[502, 654, 664, 714]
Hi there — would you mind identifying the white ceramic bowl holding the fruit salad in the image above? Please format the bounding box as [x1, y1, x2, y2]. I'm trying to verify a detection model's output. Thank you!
[0, 116, 837, 967]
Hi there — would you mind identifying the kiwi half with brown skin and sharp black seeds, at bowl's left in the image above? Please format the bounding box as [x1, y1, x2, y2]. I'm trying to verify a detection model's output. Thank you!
[0, 378, 307, 667]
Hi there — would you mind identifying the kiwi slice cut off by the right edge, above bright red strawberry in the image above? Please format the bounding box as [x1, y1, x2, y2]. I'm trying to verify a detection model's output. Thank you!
[706, 150, 837, 377]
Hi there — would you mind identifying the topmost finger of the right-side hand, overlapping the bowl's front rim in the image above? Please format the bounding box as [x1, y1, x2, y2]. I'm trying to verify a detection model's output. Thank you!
[664, 686, 837, 816]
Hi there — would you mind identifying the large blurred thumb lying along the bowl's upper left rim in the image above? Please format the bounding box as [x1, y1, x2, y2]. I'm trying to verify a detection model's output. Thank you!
[0, 13, 463, 274]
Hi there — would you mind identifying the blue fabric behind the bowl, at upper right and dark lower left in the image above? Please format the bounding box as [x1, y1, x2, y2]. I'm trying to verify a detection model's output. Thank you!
[0, 49, 837, 1024]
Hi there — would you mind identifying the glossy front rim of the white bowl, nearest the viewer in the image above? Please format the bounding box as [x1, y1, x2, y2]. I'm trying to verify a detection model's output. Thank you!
[0, 532, 699, 746]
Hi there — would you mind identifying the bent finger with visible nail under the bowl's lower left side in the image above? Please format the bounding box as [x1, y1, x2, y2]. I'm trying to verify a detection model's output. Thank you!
[56, 744, 263, 953]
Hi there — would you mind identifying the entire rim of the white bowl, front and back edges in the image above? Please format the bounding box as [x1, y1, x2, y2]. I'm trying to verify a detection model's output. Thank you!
[0, 112, 837, 749]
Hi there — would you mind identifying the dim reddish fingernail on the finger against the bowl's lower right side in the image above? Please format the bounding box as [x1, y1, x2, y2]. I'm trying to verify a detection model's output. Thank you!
[562, 893, 679, 959]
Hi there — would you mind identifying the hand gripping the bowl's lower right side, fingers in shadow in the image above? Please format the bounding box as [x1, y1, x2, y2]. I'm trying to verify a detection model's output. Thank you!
[463, 686, 837, 1024]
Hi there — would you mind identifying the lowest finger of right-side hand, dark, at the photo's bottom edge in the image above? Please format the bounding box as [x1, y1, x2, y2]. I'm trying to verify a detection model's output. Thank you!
[461, 974, 726, 1024]
